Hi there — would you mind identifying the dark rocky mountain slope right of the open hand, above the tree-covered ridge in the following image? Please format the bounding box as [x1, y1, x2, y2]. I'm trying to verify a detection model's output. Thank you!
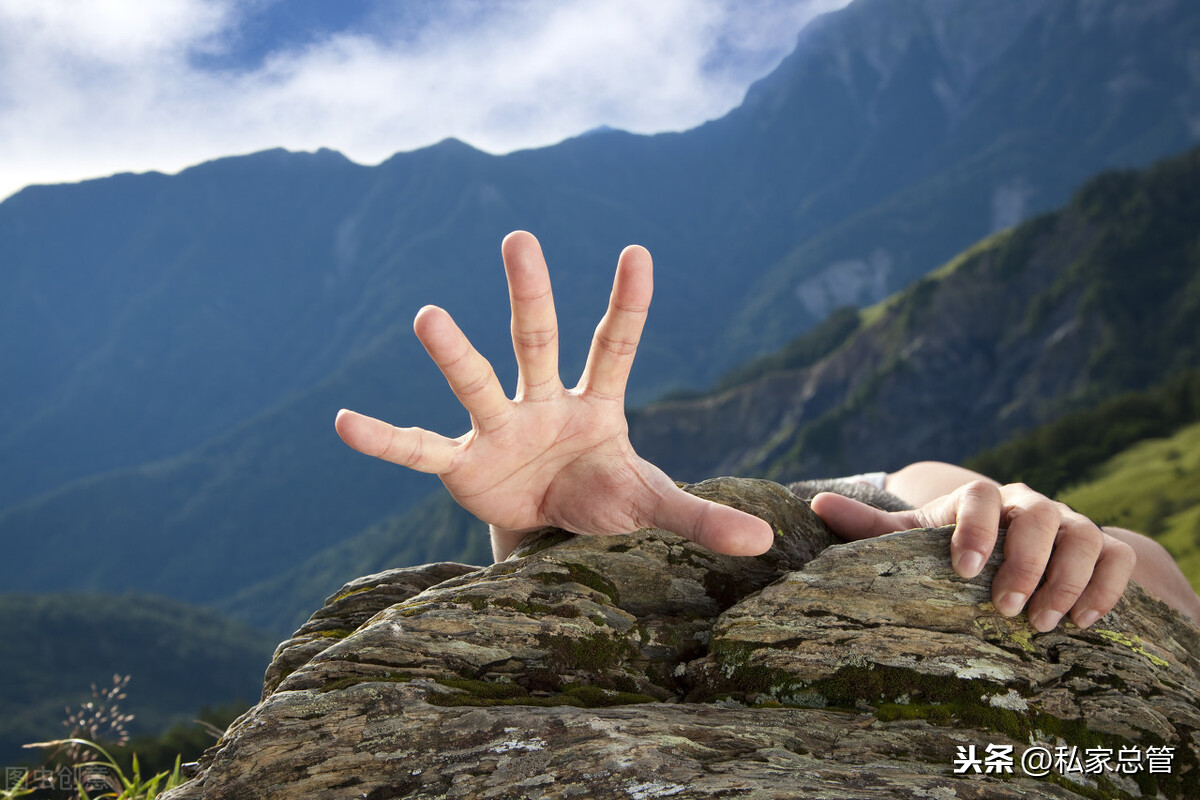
[630, 140, 1200, 480]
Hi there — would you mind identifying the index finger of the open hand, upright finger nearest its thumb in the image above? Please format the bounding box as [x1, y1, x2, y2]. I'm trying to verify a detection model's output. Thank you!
[580, 245, 654, 398]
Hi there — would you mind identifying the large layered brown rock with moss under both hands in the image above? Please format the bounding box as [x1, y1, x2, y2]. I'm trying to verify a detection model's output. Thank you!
[166, 479, 1200, 800]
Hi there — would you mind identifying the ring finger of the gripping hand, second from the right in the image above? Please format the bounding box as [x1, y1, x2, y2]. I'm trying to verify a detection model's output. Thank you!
[1025, 513, 1104, 632]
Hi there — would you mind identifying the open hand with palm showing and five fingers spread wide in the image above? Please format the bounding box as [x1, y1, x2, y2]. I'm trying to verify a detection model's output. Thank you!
[336, 231, 774, 560]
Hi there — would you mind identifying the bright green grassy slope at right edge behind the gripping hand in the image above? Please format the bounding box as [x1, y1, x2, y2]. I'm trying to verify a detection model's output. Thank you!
[1058, 423, 1200, 591]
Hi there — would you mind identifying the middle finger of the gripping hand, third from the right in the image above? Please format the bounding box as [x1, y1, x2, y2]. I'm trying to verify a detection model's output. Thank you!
[991, 483, 1062, 616]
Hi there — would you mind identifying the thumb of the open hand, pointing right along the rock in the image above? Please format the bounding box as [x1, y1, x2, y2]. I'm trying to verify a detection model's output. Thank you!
[652, 488, 775, 555]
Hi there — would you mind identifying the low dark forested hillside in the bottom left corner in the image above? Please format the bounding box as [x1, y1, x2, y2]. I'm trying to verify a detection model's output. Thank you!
[0, 594, 275, 765]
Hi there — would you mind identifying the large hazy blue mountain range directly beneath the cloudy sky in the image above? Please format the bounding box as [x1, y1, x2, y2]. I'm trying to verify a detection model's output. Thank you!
[0, 0, 1200, 603]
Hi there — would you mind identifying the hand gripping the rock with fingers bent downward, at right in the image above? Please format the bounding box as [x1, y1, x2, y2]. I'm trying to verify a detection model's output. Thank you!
[812, 480, 1138, 631]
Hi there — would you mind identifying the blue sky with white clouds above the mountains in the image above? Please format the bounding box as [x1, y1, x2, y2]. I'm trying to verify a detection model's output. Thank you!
[0, 0, 848, 198]
